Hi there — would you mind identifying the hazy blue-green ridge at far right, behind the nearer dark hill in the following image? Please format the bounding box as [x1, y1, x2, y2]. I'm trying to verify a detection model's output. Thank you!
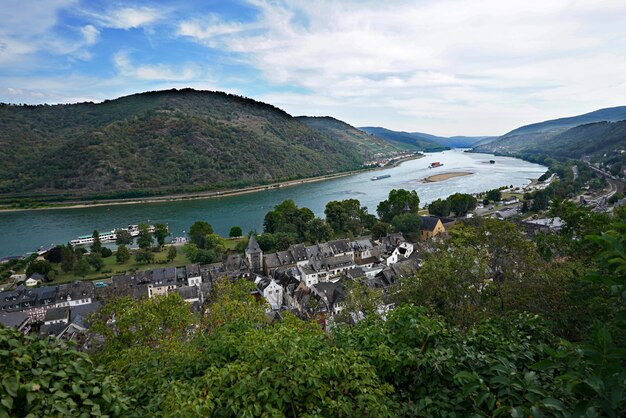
[474, 106, 626, 153]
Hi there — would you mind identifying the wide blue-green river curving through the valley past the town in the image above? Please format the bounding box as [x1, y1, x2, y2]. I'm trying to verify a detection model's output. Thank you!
[0, 150, 546, 258]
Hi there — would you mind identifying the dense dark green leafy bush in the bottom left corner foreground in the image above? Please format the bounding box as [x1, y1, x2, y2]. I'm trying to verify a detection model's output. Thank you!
[0, 326, 130, 417]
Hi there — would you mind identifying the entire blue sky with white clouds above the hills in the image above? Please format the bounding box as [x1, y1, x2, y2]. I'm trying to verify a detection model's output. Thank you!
[0, 0, 626, 136]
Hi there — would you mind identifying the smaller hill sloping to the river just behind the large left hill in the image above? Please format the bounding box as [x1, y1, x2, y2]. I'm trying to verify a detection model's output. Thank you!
[296, 116, 399, 157]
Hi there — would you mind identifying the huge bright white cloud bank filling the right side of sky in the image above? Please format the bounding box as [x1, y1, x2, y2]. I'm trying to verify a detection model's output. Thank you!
[178, 0, 626, 134]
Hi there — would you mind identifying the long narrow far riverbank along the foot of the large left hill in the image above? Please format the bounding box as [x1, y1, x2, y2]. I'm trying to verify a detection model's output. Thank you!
[0, 154, 424, 213]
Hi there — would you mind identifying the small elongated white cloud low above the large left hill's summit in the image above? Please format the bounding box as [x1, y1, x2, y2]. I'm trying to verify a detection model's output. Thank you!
[113, 51, 201, 81]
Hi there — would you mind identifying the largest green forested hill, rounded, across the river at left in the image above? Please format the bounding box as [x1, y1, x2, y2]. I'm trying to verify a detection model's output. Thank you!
[0, 89, 386, 200]
